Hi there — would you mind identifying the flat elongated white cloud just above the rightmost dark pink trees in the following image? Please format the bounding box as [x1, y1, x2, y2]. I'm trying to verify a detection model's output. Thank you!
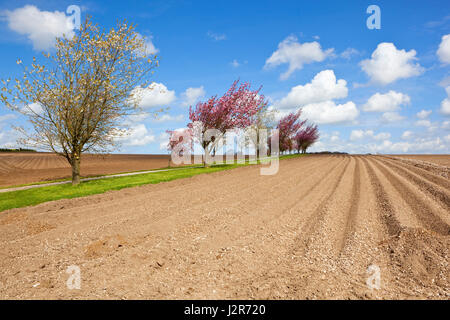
[302, 101, 359, 124]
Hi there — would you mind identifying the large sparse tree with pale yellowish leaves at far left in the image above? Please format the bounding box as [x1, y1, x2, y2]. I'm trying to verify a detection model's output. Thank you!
[0, 18, 158, 185]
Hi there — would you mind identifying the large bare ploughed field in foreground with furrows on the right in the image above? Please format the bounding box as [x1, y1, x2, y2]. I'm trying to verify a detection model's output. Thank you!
[0, 156, 450, 299]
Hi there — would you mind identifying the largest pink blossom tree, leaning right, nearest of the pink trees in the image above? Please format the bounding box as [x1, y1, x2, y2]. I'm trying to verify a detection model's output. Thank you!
[188, 80, 267, 166]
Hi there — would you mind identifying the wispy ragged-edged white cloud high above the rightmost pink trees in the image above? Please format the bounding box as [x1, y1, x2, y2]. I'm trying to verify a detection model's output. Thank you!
[264, 36, 334, 80]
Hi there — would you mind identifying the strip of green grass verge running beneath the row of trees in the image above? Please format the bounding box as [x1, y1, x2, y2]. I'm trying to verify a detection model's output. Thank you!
[0, 155, 302, 211]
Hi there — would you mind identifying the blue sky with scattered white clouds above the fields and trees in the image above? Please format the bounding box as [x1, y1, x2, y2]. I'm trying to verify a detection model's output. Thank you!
[0, 0, 450, 153]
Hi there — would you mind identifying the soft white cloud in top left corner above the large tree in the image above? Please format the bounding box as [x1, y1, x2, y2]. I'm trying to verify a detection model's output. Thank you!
[4, 5, 74, 50]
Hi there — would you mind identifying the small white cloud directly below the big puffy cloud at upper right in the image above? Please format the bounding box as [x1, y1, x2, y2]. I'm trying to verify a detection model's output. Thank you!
[363, 90, 411, 112]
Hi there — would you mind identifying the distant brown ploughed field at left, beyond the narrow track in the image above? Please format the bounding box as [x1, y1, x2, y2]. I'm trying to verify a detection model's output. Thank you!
[0, 152, 169, 187]
